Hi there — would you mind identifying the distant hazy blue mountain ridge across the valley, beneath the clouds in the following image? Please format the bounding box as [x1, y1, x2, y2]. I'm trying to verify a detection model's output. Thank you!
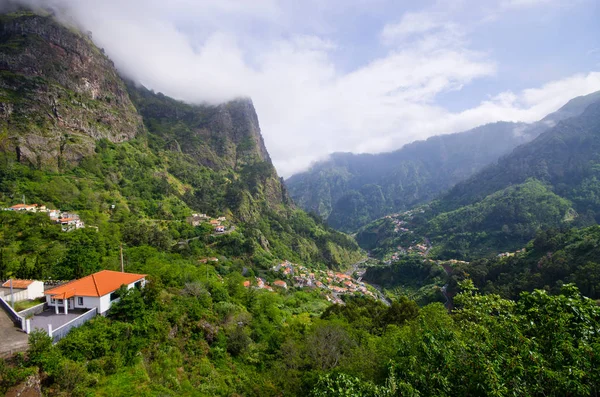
[286, 93, 600, 231]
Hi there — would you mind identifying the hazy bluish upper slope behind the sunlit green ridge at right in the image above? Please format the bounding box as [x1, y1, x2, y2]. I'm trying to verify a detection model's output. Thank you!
[439, 98, 600, 218]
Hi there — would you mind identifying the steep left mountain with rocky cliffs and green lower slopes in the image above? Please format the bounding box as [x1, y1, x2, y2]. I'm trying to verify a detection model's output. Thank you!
[0, 12, 361, 278]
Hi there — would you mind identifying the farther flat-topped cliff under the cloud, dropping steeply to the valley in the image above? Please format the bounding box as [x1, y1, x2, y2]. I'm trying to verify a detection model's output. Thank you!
[128, 84, 292, 221]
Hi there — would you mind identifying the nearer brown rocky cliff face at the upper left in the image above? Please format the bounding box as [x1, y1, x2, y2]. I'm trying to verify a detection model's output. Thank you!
[0, 12, 142, 169]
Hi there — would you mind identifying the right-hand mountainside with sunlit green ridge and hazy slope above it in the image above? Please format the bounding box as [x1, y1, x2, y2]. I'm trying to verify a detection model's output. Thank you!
[357, 95, 600, 260]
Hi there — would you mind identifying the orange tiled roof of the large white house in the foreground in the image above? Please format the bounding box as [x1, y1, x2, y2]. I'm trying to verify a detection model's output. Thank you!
[44, 270, 146, 299]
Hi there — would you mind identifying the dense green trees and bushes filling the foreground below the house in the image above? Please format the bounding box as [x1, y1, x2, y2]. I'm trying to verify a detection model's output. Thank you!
[0, 274, 600, 396]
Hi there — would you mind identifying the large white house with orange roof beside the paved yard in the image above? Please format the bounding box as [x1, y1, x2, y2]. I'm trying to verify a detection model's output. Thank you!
[44, 270, 146, 314]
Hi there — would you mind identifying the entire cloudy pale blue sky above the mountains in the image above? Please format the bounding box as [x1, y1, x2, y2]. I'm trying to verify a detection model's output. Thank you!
[12, 0, 600, 177]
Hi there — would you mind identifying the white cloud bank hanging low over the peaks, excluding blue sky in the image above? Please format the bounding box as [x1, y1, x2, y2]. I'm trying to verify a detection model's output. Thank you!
[12, 0, 600, 177]
